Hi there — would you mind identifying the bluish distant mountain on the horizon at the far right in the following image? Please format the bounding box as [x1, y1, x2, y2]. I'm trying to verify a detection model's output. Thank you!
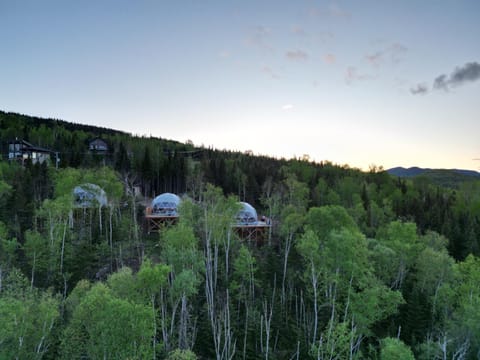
[387, 166, 480, 188]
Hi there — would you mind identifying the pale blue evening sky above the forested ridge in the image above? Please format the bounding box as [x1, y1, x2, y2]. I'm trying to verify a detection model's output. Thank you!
[0, 0, 480, 170]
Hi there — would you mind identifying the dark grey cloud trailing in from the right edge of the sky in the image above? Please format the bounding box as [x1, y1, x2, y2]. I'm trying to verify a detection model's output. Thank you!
[410, 62, 480, 95]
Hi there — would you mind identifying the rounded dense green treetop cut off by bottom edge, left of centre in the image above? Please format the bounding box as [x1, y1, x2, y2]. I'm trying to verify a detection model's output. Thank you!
[61, 283, 153, 359]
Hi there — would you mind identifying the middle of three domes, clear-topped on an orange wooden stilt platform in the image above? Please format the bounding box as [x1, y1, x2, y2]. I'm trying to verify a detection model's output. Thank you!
[145, 193, 182, 234]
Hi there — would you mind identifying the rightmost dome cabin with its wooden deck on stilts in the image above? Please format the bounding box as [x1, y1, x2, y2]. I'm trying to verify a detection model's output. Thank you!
[233, 202, 271, 245]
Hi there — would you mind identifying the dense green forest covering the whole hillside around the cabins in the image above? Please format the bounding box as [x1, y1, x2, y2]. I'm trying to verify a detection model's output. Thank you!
[0, 112, 480, 360]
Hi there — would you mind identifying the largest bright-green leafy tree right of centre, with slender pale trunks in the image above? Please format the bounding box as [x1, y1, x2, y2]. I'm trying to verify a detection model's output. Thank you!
[297, 206, 403, 359]
